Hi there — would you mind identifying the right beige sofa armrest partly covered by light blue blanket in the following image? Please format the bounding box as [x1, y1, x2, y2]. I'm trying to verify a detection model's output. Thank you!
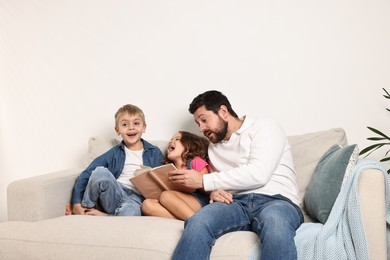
[359, 169, 387, 260]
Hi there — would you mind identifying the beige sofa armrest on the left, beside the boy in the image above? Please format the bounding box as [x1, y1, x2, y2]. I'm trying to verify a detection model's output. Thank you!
[7, 168, 82, 221]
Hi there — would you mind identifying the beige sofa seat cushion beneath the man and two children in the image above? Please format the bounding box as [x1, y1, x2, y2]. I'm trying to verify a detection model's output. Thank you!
[0, 215, 259, 260]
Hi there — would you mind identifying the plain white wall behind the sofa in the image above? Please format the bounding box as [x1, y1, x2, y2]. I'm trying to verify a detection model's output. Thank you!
[0, 0, 390, 221]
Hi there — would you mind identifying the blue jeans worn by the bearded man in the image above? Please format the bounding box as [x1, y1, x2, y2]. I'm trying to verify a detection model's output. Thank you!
[172, 193, 303, 260]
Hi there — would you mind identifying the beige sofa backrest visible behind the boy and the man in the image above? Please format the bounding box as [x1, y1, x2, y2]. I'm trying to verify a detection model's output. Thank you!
[86, 128, 348, 213]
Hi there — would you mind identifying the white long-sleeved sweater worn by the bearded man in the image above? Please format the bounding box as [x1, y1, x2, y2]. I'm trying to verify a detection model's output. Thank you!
[203, 116, 301, 205]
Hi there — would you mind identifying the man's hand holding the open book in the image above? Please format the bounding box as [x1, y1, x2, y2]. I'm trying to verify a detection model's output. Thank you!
[169, 170, 203, 189]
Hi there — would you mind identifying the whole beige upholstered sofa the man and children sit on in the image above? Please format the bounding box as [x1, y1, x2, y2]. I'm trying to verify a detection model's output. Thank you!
[0, 128, 387, 260]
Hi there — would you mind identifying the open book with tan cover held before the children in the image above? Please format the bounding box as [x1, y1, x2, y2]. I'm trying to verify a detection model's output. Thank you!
[130, 163, 195, 199]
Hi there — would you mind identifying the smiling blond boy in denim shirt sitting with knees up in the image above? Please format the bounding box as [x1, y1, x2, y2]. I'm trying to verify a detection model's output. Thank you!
[65, 104, 163, 216]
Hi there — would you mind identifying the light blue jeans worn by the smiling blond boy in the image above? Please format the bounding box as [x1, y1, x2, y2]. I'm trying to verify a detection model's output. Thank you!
[81, 167, 144, 216]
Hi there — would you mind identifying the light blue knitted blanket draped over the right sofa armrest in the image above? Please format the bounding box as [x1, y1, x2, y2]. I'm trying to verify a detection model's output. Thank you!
[250, 160, 390, 260]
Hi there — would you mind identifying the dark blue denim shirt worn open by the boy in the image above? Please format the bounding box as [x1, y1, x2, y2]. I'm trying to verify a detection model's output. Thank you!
[72, 138, 163, 204]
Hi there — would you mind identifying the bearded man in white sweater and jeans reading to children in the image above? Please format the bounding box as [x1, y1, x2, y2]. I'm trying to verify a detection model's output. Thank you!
[170, 90, 303, 260]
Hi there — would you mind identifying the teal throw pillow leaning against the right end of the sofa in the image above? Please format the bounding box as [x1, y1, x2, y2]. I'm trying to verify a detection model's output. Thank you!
[304, 144, 359, 223]
